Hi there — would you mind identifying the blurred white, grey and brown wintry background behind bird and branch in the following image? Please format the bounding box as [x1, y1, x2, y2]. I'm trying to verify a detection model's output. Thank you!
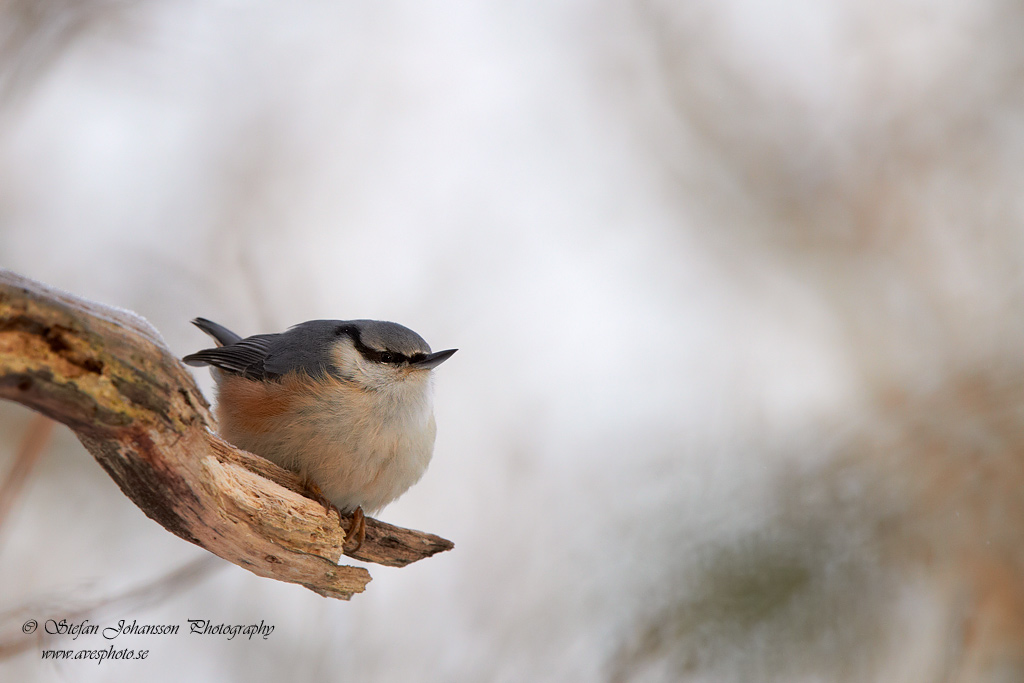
[0, 0, 1024, 682]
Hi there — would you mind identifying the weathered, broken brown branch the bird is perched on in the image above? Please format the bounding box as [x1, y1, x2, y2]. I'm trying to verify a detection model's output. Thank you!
[0, 269, 453, 600]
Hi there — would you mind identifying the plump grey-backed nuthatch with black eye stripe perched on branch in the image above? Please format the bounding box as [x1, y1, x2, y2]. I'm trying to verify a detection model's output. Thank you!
[182, 317, 458, 552]
